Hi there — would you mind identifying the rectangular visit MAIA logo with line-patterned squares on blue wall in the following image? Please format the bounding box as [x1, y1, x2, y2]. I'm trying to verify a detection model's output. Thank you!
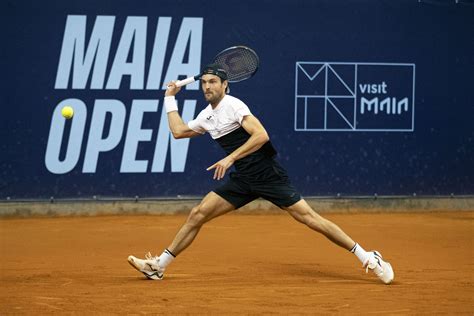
[294, 61, 415, 132]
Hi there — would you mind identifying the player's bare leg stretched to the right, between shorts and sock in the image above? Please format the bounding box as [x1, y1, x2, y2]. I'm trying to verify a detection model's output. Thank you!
[282, 199, 355, 250]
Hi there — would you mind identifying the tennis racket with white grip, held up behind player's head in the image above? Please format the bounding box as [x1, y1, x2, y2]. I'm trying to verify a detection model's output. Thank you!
[176, 46, 259, 87]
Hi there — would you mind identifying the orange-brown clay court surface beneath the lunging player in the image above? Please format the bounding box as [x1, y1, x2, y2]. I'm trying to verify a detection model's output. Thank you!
[0, 212, 474, 315]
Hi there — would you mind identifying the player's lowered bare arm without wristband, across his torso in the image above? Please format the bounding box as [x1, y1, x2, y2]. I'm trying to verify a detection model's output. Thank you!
[207, 115, 270, 180]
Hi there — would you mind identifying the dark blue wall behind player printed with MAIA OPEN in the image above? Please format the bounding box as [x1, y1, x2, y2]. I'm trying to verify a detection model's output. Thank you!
[0, 0, 474, 199]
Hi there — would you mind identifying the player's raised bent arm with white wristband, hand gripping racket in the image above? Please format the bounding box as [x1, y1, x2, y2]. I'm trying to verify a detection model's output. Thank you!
[165, 82, 201, 138]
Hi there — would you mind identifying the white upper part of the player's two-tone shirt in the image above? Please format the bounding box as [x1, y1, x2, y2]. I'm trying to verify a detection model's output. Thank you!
[188, 95, 252, 139]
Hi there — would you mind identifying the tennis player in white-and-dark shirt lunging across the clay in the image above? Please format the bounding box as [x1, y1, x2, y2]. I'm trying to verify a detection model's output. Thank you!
[128, 64, 394, 284]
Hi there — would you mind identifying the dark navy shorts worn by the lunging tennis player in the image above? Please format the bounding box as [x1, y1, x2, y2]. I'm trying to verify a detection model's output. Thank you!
[213, 159, 301, 209]
